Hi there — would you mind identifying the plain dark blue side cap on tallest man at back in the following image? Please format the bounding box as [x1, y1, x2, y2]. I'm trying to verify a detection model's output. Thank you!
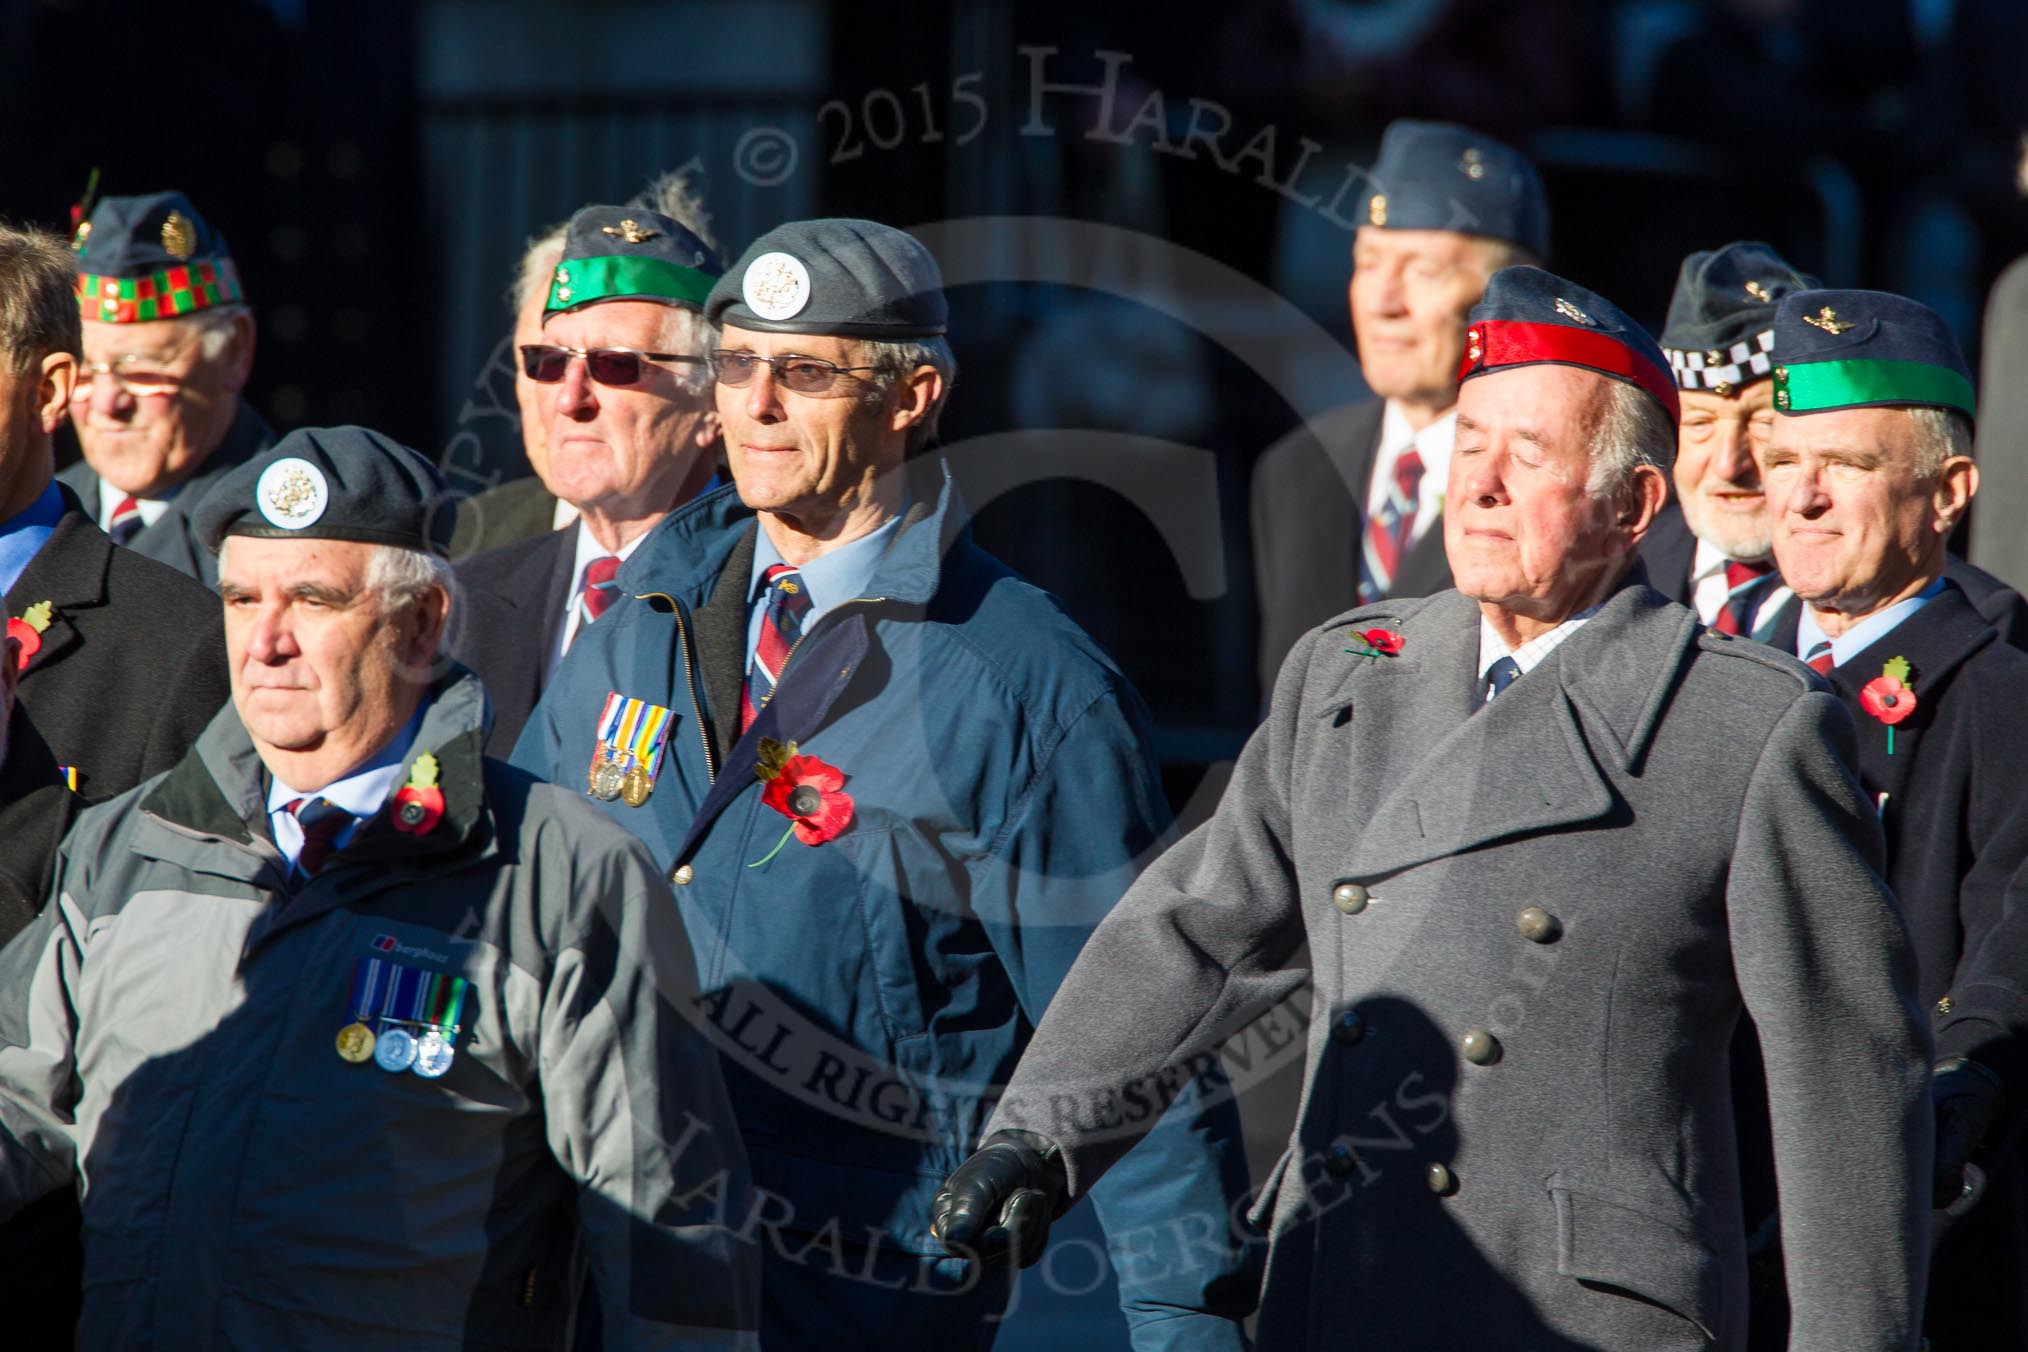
[1355, 118, 1549, 259]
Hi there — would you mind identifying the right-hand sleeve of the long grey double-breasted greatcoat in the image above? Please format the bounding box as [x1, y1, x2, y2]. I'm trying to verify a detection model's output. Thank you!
[1726, 691, 1931, 1352]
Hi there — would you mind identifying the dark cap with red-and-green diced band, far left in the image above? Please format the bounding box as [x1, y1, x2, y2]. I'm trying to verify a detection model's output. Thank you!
[71, 193, 243, 324]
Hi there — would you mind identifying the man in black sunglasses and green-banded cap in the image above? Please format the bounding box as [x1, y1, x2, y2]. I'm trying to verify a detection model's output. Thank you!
[452, 205, 724, 756]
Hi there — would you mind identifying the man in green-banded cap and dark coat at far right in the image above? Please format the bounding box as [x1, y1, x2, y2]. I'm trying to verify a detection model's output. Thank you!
[1764, 290, 2028, 1352]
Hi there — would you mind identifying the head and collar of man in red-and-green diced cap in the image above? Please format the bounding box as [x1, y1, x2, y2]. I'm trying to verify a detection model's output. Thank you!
[61, 193, 274, 586]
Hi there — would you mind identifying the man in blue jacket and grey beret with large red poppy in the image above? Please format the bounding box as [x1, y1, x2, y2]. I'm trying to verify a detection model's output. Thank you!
[515, 221, 1251, 1352]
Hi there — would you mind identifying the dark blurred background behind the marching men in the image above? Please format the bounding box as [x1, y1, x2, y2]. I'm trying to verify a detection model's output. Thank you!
[0, 0, 2028, 1346]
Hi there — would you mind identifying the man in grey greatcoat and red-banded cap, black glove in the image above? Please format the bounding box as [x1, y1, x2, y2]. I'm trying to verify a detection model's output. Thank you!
[939, 268, 1931, 1352]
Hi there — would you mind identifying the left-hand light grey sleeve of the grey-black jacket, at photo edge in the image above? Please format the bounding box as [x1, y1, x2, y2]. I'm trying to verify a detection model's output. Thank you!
[0, 837, 85, 1220]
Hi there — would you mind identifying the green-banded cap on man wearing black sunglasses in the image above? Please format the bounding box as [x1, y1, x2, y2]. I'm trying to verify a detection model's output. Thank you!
[544, 207, 726, 318]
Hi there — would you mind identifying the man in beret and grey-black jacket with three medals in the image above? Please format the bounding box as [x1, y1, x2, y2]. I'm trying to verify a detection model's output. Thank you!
[0, 428, 756, 1352]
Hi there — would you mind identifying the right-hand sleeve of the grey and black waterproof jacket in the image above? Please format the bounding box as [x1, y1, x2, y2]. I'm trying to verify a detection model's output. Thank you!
[537, 829, 761, 1352]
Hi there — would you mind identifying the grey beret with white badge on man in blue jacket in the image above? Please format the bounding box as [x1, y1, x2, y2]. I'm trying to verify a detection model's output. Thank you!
[704, 219, 949, 341]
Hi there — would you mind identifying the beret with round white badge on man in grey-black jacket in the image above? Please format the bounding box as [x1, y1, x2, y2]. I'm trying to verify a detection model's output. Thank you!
[193, 428, 458, 553]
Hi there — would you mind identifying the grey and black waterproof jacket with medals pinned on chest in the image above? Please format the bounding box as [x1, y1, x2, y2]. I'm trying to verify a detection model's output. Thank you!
[0, 667, 758, 1352]
